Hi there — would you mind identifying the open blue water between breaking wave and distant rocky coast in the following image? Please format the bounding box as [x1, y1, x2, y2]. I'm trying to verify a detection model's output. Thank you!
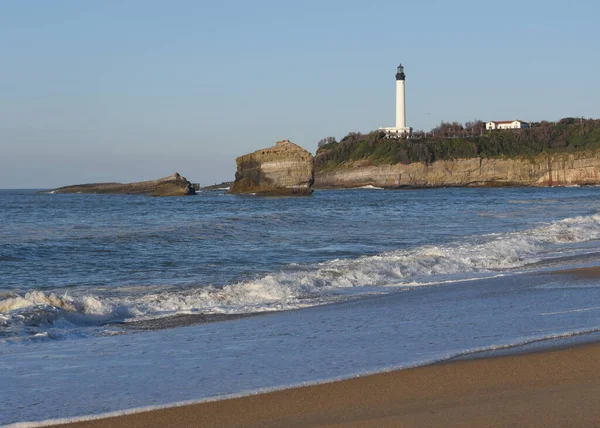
[0, 188, 600, 293]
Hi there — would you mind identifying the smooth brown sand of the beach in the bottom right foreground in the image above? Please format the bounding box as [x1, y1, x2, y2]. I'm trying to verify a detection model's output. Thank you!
[57, 343, 600, 428]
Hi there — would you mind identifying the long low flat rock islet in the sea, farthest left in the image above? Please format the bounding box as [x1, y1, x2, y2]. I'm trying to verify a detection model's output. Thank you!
[52, 173, 196, 196]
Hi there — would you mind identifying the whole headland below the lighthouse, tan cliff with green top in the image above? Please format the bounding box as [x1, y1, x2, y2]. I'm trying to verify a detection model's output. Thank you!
[314, 118, 600, 188]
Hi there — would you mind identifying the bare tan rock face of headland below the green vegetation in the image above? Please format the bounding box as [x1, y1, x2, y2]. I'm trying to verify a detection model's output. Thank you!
[315, 152, 600, 188]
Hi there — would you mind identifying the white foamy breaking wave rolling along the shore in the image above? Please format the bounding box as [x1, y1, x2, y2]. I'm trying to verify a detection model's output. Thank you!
[0, 214, 600, 337]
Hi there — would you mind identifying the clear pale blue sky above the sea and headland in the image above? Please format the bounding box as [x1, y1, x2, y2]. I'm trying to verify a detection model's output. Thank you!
[0, 0, 600, 188]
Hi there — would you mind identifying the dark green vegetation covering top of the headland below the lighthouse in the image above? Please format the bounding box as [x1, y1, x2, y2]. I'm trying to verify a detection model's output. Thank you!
[315, 118, 600, 171]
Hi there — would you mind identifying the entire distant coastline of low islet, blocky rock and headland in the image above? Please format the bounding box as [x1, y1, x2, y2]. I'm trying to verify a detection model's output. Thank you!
[35, 118, 600, 196]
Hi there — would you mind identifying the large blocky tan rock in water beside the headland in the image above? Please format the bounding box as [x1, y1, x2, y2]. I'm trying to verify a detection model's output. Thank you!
[229, 140, 315, 196]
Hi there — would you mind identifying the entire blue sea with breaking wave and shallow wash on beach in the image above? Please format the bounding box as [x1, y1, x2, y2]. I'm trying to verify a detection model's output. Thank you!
[0, 187, 600, 426]
